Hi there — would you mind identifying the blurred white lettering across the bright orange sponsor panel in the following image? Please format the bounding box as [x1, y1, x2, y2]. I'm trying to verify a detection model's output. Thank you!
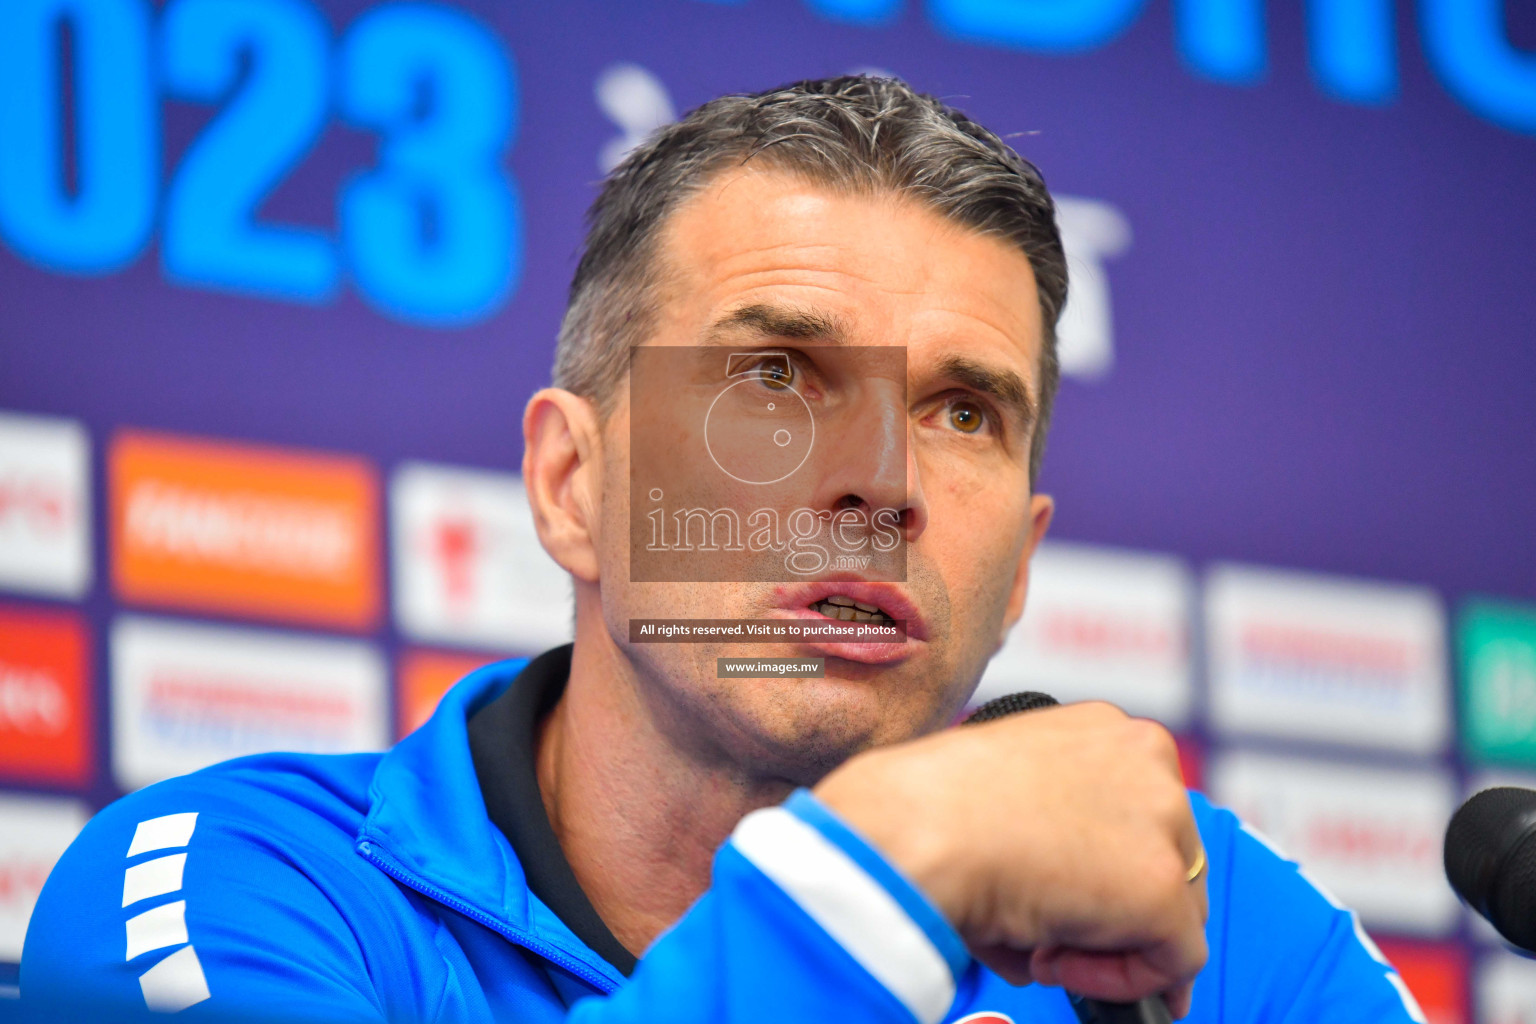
[124, 481, 358, 577]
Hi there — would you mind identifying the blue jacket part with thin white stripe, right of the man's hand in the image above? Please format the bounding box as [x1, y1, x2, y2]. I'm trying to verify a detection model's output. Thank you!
[1195, 797, 1425, 1024]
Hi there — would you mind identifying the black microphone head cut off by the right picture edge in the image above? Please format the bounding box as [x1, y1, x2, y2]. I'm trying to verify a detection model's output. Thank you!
[1445, 786, 1536, 953]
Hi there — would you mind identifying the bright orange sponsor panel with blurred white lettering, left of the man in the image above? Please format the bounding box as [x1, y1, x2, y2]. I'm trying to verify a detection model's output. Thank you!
[111, 433, 381, 629]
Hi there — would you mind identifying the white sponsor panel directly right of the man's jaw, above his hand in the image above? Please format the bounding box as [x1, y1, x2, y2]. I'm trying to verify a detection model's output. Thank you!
[972, 543, 1193, 726]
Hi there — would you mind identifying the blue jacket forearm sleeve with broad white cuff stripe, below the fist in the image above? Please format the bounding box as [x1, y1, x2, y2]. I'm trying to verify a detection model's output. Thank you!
[568, 791, 974, 1024]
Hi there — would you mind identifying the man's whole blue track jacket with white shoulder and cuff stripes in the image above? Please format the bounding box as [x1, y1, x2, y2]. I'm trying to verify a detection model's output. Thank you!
[18, 660, 1424, 1024]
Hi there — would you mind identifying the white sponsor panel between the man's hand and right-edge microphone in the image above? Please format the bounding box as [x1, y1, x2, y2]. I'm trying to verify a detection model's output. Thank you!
[1206, 751, 1461, 936]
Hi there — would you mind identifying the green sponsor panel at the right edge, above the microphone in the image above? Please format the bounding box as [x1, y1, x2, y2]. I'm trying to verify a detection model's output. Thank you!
[1456, 600, 1536, 766]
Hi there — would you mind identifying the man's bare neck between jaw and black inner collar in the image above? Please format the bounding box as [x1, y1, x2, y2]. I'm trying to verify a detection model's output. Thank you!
[536, 614, 791, 956]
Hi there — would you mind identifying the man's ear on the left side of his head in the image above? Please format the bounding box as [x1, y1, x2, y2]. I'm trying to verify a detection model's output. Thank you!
[522, 387, 602, 583]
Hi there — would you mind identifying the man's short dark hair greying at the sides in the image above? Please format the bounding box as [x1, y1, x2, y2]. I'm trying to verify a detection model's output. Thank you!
[554, 75, 1066, 485]
